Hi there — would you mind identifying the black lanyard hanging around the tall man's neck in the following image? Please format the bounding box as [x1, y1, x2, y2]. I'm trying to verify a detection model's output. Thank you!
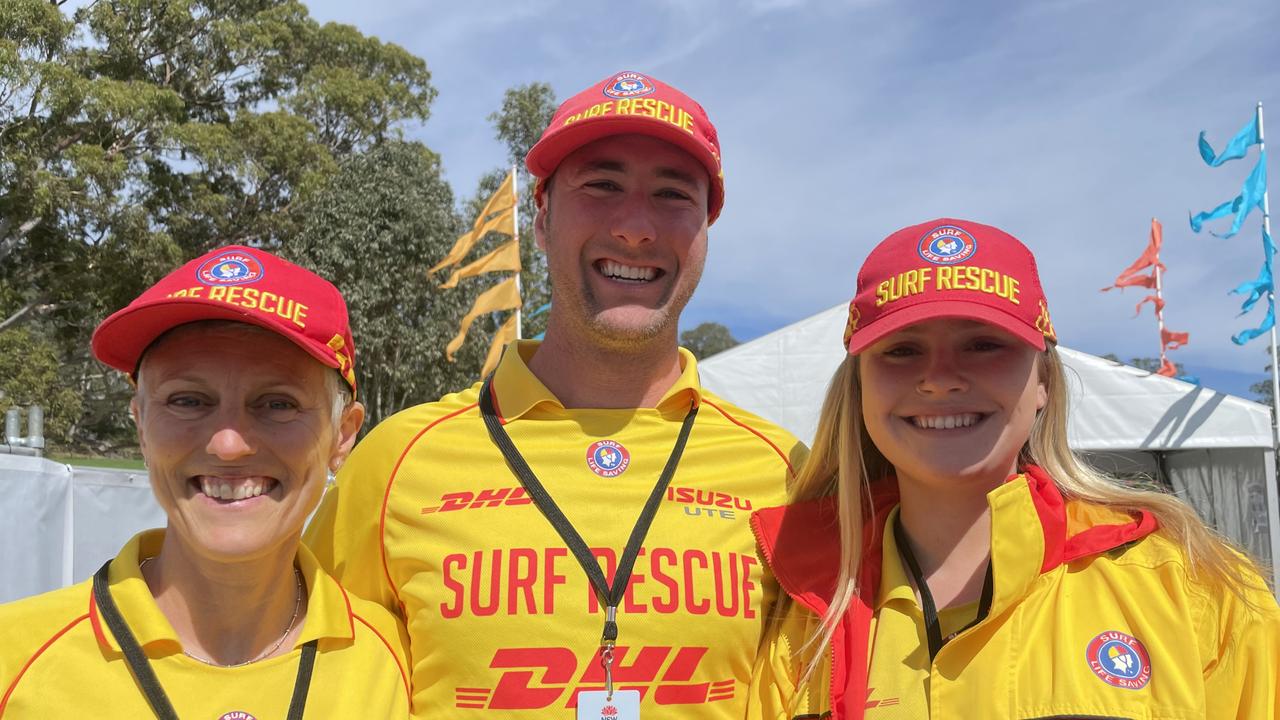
[480, 375, 698, 647]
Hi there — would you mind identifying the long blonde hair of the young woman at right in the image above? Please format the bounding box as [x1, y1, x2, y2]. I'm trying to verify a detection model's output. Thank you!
[778, 343, 1265, 684]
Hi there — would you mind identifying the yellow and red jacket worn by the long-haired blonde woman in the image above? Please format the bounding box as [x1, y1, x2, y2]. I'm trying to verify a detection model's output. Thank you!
[748, 468, 1280, 720]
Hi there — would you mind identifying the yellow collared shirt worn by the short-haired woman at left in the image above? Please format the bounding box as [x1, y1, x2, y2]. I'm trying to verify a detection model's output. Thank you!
[0, 530, 408, 720]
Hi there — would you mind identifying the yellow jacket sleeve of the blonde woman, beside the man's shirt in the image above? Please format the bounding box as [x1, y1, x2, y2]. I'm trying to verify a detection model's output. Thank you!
[746, 600, 831, 720]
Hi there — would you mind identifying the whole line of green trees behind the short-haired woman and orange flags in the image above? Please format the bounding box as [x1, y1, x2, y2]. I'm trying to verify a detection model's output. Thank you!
[0, 0, 554, 452]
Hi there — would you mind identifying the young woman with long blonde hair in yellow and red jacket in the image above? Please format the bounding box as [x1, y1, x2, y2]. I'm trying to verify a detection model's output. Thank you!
[750, 219, 1280, 720]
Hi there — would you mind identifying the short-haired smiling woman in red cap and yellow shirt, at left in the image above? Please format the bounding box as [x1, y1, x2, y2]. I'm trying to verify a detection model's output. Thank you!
[0, 246, 410, 720]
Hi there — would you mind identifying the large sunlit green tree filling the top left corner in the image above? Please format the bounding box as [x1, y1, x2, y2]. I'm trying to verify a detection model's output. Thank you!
[0, 0, 435, 447]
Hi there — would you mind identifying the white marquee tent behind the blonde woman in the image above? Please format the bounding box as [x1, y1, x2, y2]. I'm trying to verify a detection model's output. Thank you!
[698, 305, 1280, 587]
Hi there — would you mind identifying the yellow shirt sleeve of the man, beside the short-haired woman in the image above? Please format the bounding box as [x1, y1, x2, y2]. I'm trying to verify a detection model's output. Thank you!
[302, 420, 402, 615]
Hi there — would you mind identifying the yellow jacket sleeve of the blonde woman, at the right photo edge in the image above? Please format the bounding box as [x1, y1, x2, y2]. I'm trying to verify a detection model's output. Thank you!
[1201, 568, 1280, 720]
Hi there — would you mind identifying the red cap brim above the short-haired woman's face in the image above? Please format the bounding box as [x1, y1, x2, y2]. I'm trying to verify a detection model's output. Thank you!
[90, 297, 338, 377]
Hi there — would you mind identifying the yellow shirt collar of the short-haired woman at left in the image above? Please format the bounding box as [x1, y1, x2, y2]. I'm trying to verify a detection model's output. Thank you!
[90, 529, 356, 655]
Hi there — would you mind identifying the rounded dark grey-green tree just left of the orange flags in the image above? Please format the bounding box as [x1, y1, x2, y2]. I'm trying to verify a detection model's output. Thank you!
[283, 142, 488, 430]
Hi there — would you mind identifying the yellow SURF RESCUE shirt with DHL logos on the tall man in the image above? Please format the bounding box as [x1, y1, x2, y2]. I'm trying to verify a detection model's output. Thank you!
[306, 342, 803, 720]
